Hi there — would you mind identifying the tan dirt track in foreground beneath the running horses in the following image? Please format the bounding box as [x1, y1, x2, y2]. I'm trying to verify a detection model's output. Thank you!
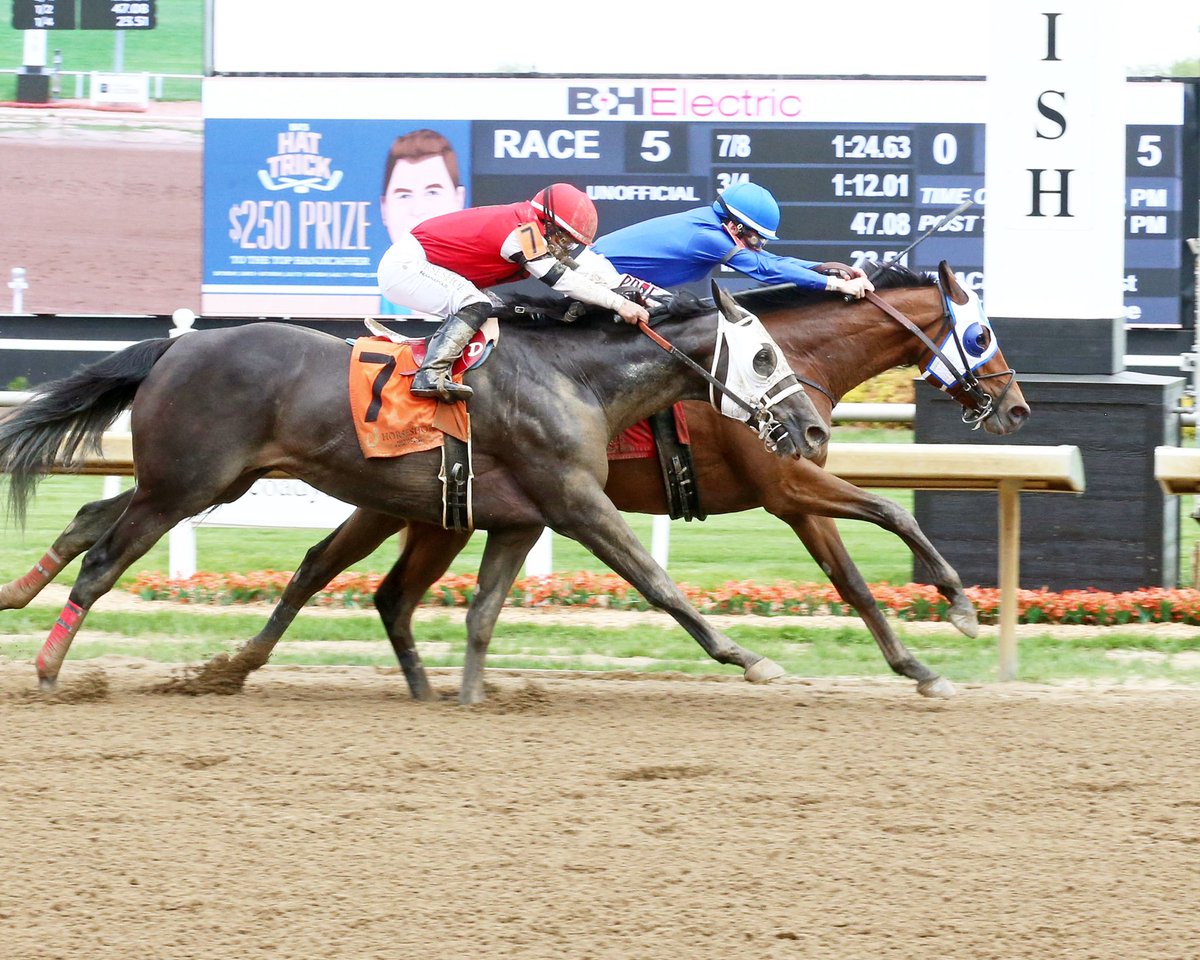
[0, 659, 1200, 960]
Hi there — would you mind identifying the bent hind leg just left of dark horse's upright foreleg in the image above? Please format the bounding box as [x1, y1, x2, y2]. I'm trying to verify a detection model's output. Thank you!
[374, 523, 472, 700]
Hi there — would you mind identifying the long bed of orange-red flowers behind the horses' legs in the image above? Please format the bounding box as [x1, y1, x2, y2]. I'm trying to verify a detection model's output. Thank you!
[130, 570, 1200, 626]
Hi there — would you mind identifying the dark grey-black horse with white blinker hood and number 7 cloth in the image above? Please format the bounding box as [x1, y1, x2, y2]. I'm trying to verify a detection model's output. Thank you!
[0, 283, 829, 703]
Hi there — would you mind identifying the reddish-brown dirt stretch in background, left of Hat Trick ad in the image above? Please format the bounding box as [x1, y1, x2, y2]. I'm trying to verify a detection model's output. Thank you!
[0, 103, 204, 314]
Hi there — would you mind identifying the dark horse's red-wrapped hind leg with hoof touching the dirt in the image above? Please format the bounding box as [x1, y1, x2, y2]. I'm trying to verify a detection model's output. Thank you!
[37, 491, 195, 690]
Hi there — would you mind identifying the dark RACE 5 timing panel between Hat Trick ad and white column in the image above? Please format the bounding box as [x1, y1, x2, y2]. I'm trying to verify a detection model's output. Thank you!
[472, 121, 985, 300]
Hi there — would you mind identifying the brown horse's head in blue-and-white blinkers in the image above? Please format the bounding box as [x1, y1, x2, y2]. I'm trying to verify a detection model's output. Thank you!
[920, 260, 1030, 436]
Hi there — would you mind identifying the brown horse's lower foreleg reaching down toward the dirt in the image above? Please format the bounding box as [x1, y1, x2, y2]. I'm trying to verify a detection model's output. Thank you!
[784, 514, 955, 697]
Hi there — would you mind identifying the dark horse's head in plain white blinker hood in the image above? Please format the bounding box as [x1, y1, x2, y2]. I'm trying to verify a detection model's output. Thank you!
[709, 281, 829, 458]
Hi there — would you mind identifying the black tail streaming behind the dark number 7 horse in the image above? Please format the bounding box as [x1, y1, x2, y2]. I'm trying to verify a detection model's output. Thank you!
[0, 338, 176, 527]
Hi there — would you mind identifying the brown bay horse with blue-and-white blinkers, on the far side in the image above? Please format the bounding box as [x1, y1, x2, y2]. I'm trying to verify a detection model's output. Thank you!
[0, 264, 1028, 696]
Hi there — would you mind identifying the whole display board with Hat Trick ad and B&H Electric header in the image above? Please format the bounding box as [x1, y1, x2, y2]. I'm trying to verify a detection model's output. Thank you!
[202, 77, 1196, 326]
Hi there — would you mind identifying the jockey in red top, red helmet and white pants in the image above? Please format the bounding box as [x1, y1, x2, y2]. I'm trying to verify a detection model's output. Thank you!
[378, 184, 649, 403]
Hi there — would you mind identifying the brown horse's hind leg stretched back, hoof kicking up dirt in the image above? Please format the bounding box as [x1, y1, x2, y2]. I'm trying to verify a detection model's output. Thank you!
[193, 510, 404, 694]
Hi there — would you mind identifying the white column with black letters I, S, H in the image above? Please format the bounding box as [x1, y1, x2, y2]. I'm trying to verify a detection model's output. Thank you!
[984, 0, 1126, 320]
